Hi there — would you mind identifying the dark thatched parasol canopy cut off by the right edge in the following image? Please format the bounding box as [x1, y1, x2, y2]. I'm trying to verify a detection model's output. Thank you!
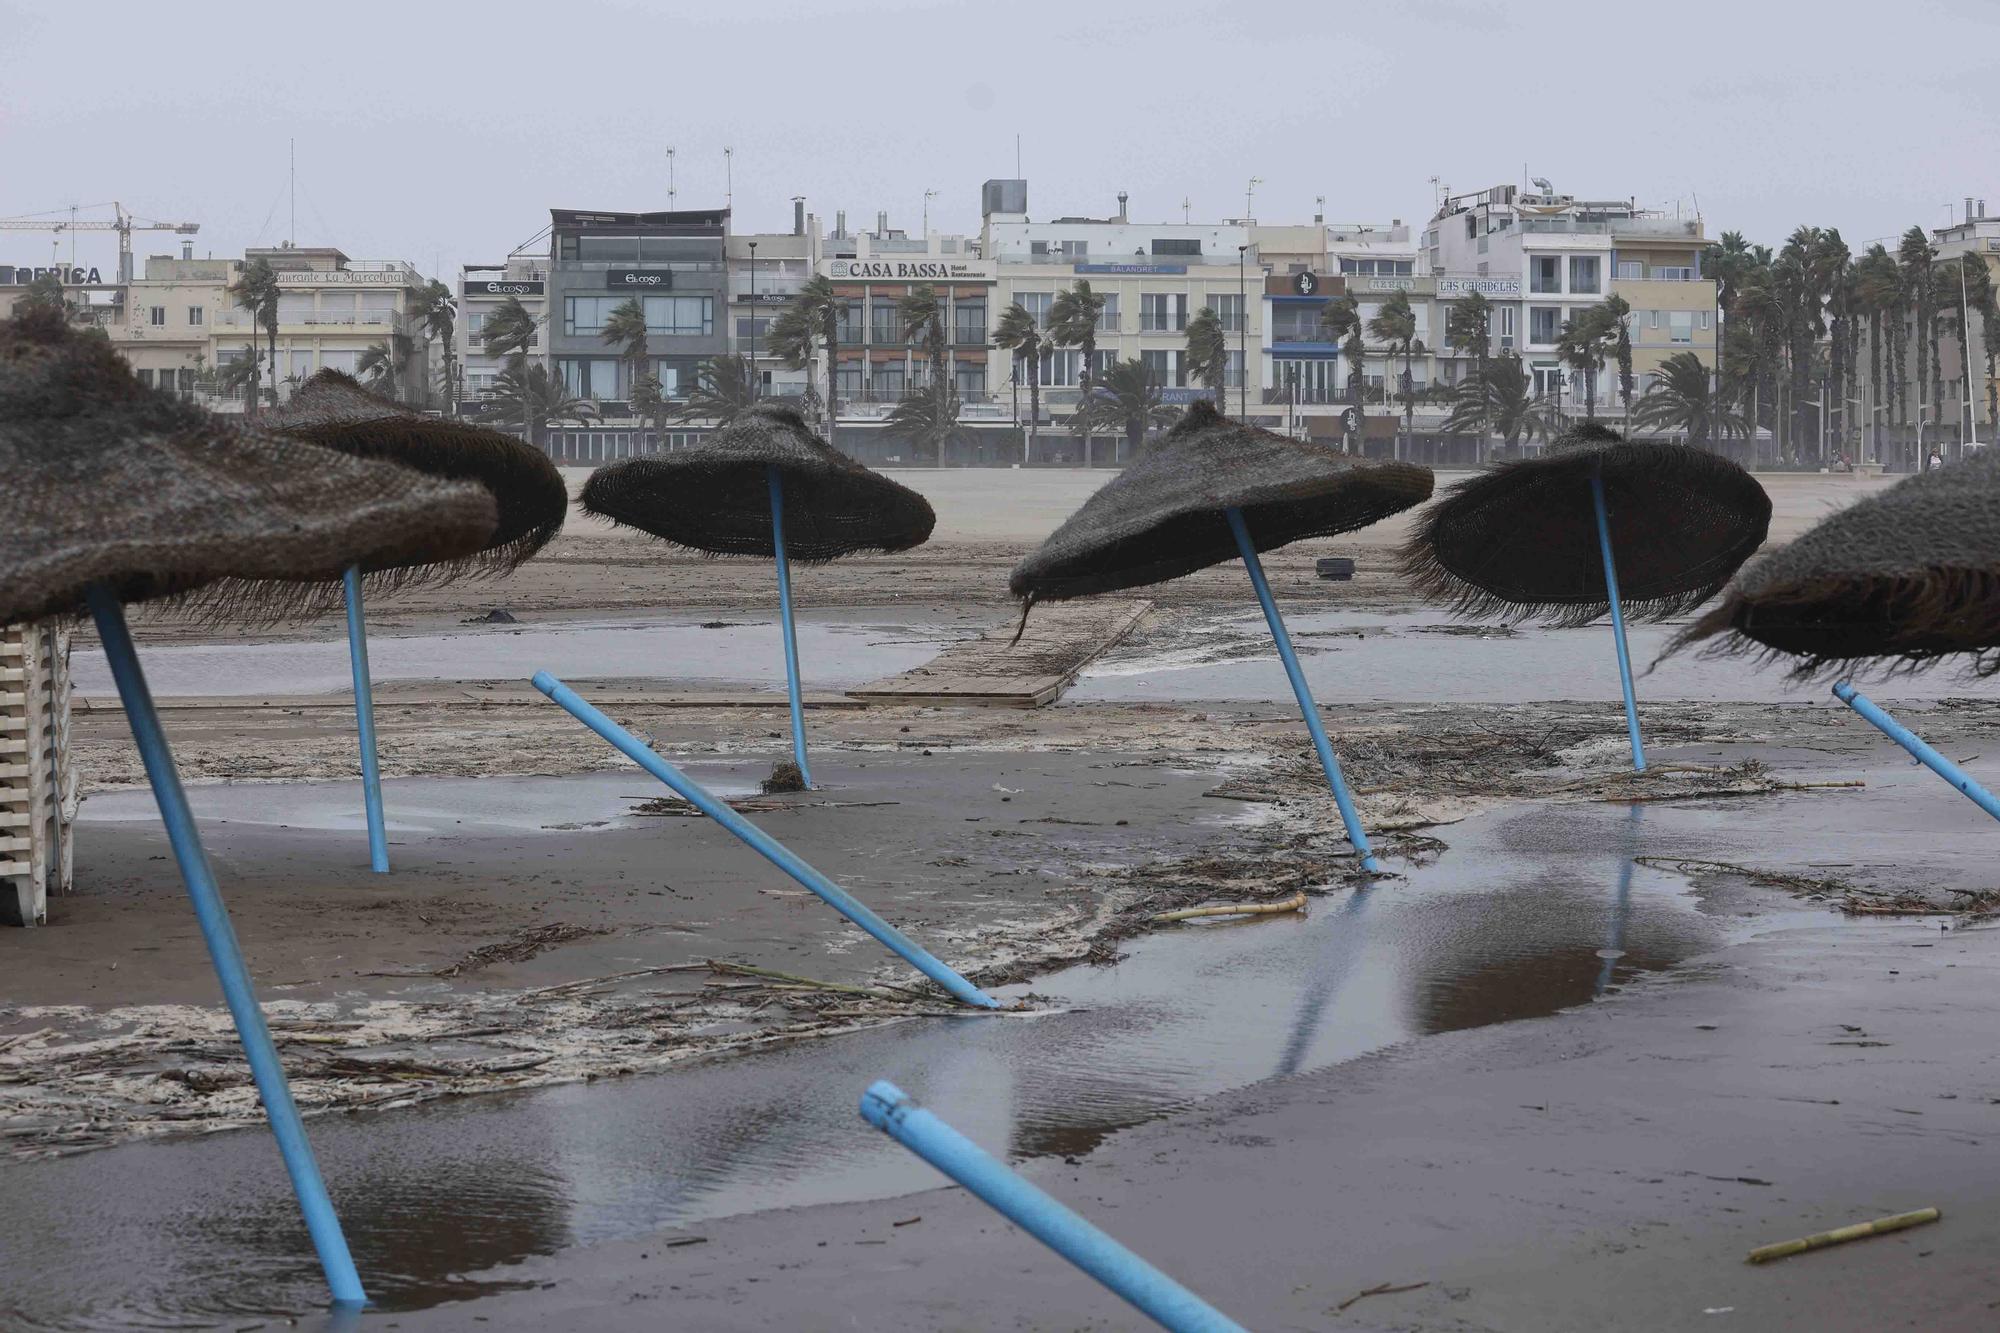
[1674, 450, 2000, 677]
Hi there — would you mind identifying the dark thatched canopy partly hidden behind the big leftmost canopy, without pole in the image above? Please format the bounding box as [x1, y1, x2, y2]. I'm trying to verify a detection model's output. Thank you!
[260, 370, 570, 572]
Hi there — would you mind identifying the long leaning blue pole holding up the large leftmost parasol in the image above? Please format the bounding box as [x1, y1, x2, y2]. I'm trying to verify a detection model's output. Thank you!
[90, 586, 368, 1303]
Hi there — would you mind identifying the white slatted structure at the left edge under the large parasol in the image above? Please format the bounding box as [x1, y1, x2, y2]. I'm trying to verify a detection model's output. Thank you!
[0, 622, 76, 925]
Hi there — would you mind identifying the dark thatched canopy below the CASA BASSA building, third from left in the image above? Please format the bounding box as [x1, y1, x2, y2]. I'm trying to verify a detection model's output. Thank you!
[582, 402, 938, 562]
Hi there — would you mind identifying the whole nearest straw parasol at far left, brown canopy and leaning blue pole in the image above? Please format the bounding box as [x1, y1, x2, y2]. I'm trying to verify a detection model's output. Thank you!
[0, 312, 494, 1303]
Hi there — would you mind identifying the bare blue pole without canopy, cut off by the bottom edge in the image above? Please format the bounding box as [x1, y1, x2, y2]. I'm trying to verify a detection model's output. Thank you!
[862, 1081, 1244, 1333]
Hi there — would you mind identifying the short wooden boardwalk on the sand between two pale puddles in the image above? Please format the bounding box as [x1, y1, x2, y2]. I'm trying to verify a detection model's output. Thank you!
[848, 598, 1152, 709]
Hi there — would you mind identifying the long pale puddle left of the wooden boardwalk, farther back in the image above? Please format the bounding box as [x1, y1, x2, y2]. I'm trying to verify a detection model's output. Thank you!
[74, 612, 964, 697]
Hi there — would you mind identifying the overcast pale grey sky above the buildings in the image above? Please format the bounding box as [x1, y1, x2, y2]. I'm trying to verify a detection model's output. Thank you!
[0, 0, 2000, 276]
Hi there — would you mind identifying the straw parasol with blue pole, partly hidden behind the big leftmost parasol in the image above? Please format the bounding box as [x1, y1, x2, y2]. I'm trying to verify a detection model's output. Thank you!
[256, 370, 570, 875]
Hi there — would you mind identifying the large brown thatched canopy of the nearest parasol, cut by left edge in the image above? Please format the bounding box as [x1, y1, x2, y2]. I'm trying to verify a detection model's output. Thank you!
[0, 312, 494, 622]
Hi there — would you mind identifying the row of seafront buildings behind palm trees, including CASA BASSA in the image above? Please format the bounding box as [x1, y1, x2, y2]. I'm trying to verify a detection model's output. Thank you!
[0, 180, 2000, 462]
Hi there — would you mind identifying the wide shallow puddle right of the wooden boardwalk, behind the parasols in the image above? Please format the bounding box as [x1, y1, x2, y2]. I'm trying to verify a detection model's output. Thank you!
[1066, 604, 1978, 705]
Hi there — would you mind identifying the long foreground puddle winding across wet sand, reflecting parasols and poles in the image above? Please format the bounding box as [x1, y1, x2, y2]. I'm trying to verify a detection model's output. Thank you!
[0, 783, 1888, 1329]
